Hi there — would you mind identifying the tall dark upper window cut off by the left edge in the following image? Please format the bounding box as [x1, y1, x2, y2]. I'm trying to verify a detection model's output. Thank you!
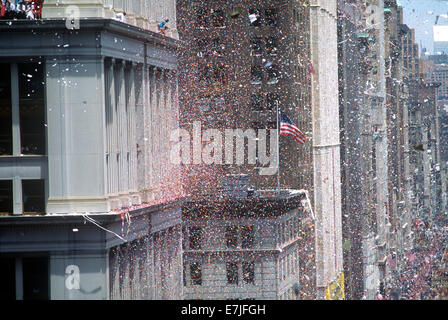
[0, 63, 12, 156]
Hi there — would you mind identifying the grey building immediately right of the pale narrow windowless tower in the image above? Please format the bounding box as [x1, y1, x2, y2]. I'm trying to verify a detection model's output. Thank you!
[338, 1, 376, 300]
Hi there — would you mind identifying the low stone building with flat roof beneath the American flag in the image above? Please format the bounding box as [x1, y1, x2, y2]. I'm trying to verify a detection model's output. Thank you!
[182, 190, 315, 300]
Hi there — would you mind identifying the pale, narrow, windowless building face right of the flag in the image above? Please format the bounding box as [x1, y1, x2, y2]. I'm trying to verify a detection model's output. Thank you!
[310, 0, 343, 299]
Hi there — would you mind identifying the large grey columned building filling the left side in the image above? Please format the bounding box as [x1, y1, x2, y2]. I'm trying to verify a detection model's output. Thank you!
[0, 1, 182, 300]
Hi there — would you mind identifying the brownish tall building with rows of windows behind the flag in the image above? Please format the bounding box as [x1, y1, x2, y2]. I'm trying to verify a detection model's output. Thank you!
[177, 0, 313, 196]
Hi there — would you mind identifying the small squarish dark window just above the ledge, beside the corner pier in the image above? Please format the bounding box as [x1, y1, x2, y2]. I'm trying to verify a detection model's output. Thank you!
[22, 180, 45, 214]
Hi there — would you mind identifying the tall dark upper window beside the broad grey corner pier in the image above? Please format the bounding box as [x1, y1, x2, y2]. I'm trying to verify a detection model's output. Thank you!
[18, 63, 45, 155]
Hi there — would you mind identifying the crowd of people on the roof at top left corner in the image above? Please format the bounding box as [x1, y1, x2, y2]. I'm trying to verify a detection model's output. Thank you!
[0, 0, 44, 20]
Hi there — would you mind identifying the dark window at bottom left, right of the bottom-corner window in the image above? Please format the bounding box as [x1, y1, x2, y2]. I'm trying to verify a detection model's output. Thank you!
[23, 258, 50, 300]
